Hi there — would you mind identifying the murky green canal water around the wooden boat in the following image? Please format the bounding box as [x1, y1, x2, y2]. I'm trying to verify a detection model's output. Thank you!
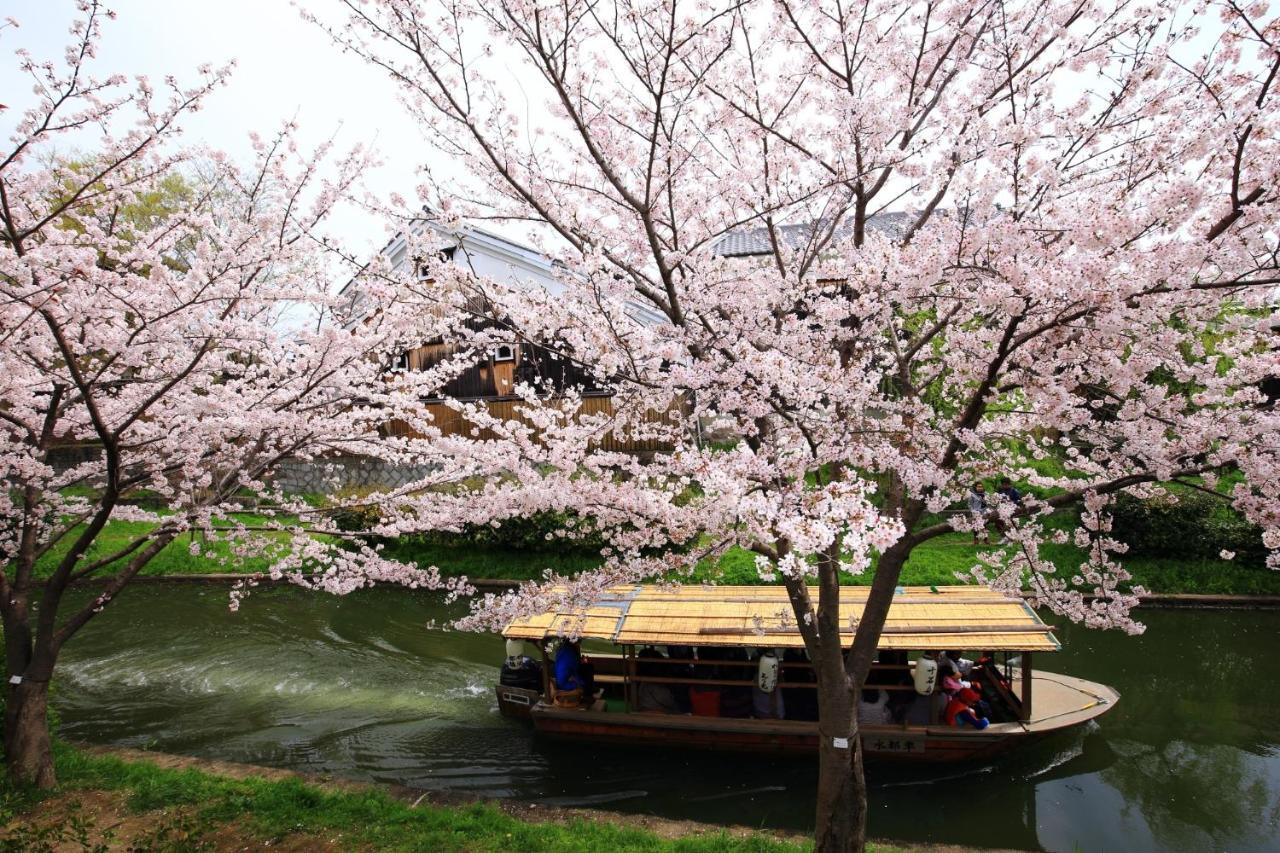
[55, 584, 1280, 852]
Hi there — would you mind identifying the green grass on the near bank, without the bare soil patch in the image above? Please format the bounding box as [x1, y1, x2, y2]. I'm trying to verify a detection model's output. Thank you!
[0, 743, 899, 853]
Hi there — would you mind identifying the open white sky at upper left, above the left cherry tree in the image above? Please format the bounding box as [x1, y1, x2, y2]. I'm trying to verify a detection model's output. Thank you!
[0, 0, 440, 262]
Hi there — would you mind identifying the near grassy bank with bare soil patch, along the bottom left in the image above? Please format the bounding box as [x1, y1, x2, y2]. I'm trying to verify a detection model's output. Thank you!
[0, 744, 942, 853]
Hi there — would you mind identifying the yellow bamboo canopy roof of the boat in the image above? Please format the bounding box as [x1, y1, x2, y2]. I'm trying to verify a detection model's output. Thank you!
[503, 584, 1061, 652]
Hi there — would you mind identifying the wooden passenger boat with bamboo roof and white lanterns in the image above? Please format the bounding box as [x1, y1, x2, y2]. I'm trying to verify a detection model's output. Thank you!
[497, 585, 1119, 762]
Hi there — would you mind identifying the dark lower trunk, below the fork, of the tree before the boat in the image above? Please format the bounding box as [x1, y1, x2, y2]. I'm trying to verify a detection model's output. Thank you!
[814, 684, 867, 853]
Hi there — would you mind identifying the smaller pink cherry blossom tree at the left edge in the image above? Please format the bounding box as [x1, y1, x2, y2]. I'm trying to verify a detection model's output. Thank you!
[0, 1, 481, 786]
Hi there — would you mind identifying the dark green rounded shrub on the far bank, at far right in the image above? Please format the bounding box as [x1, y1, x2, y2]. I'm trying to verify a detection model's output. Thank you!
[1112, 489, 1266, 565]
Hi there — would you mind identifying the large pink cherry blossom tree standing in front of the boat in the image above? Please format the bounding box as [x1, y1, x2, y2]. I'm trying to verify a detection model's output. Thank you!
[332, 0, 1280, 850]
